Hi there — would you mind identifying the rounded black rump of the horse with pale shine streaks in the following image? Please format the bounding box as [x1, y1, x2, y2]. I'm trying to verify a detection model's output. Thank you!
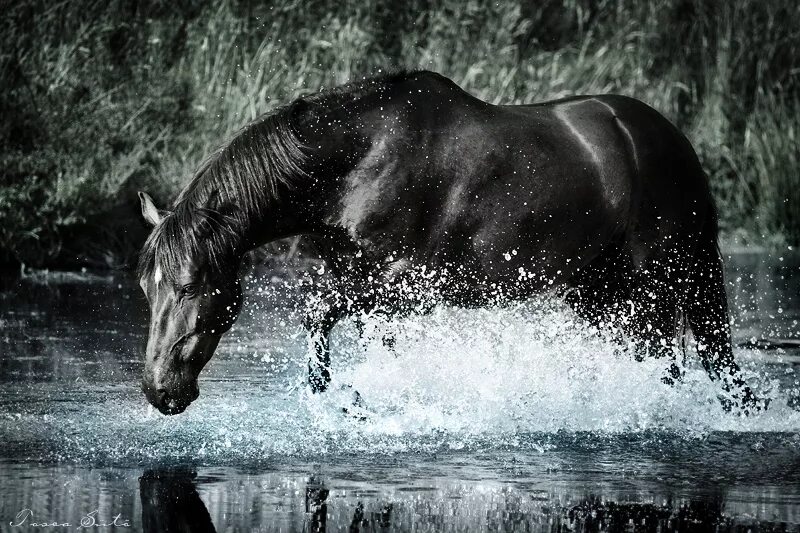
[504, 95, 713, 251]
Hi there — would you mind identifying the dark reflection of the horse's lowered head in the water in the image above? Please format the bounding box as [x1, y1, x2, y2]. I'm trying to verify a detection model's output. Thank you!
[139, 468, 216, 533]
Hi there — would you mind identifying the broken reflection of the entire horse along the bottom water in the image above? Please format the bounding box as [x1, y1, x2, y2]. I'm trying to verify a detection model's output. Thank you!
[128, 468, 752, 533]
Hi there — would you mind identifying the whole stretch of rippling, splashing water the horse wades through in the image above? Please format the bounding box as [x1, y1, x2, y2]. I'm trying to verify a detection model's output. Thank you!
[0, 253, 800, 531]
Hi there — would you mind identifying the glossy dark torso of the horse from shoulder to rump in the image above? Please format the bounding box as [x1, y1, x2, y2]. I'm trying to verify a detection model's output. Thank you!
[332, 72, 708, 286]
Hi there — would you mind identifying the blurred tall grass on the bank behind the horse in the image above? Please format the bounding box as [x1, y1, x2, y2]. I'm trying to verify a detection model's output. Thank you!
[0, 0, 800, 268]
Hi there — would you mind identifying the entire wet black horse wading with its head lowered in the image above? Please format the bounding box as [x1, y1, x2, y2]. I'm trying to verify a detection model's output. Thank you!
[139, 67, 761, 414]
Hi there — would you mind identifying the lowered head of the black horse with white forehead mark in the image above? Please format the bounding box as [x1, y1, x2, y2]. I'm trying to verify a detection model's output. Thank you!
[139, 193, 242, 415]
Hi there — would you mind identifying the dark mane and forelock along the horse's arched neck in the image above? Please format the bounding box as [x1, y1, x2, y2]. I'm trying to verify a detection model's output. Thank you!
[137, 71, 412, 282]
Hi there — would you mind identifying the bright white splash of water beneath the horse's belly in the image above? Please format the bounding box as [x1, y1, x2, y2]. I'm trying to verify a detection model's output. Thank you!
[315, 299, 800, 436]
